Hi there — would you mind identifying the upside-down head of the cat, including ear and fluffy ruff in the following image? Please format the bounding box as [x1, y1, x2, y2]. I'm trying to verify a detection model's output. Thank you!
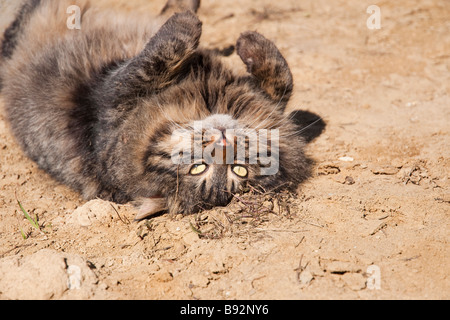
[134, 64, 308, 217]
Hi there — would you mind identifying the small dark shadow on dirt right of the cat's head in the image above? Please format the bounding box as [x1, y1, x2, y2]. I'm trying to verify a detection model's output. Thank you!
[289, 110, 326, 143]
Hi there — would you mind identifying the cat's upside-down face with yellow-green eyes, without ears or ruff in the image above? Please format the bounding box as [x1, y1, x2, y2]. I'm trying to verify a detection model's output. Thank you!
[168, 114, 279, 212]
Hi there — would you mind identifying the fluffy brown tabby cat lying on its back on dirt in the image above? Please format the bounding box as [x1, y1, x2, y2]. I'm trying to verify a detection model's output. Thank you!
[0, 0, 310, 219]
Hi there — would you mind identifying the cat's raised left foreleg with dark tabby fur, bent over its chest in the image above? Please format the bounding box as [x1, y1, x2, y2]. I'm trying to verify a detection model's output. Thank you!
[100, 11, 202, 101]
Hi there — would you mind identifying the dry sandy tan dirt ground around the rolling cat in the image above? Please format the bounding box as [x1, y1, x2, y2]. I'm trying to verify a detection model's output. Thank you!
[0, 0, 450, 299]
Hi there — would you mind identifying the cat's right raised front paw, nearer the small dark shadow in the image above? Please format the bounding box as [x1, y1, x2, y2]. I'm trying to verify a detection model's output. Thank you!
[236, 31, 293, 110]
